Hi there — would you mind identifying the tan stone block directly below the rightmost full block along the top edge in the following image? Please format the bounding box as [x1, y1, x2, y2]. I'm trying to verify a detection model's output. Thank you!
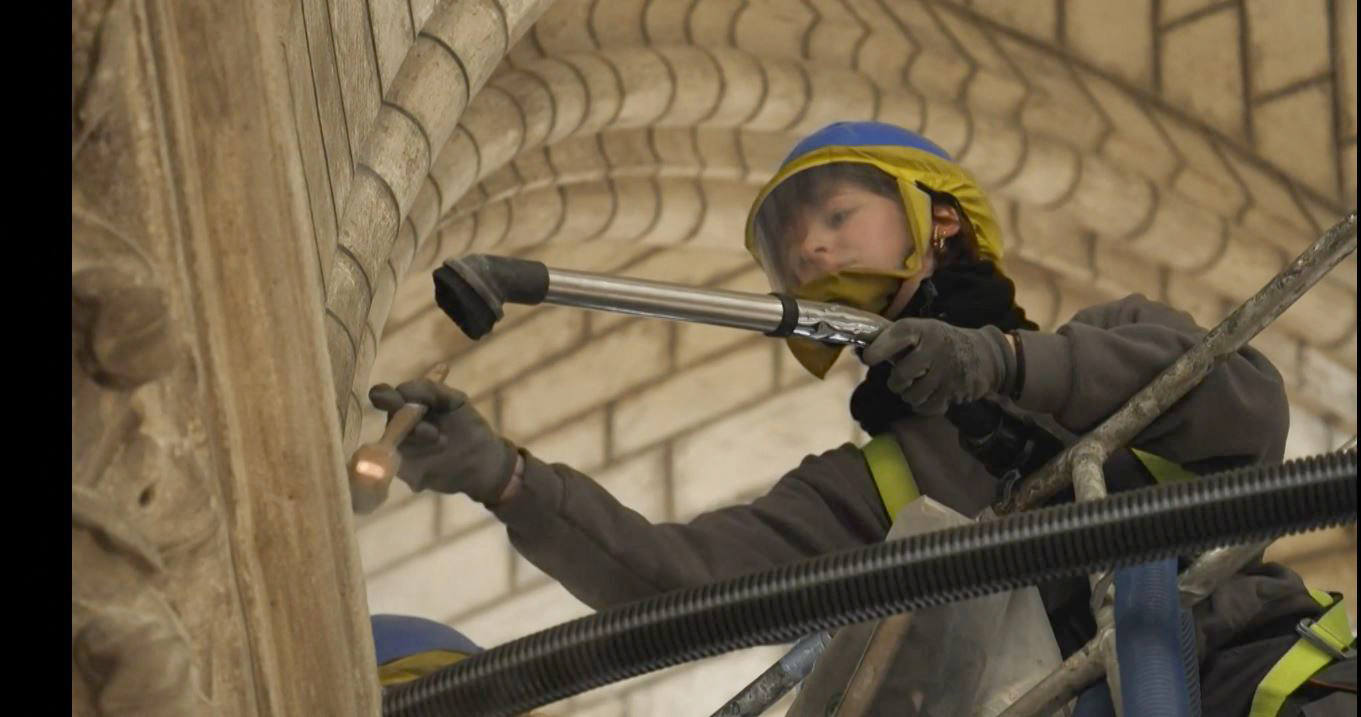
[1252, 84, 1338, 196]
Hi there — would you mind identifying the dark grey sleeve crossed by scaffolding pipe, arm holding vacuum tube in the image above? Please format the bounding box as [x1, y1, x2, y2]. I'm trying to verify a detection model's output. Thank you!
[1017, 294, 1290, 471]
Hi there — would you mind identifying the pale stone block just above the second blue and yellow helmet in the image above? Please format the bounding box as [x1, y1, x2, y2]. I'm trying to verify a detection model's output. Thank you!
[367, 522, 510, 620]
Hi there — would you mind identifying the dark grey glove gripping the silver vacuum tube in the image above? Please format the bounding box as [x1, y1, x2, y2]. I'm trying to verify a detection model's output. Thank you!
[863, 318, 1015, 416]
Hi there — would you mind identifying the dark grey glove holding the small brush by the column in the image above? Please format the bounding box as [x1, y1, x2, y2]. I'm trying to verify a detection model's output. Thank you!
[369, 378, 517, 505]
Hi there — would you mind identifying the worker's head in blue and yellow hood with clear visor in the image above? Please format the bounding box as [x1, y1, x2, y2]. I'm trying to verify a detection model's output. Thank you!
[747, 122, 1002, 376]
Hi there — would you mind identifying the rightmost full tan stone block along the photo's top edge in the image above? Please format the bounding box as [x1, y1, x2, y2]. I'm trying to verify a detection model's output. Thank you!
[1243, 0, 1330, 95]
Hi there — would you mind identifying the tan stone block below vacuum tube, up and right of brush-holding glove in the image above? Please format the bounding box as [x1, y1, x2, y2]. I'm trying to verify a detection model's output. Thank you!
[502, 322, 667, 435]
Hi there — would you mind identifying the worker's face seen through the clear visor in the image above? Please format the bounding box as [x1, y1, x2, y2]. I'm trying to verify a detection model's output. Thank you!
[783, 181, 913, 286]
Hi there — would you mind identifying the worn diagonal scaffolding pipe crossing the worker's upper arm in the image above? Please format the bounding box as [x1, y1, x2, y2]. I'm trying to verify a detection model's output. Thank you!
[994, 210, 1357, 516]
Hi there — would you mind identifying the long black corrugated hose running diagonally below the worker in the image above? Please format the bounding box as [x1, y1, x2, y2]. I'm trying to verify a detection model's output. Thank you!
[382, 449, 1357, 717]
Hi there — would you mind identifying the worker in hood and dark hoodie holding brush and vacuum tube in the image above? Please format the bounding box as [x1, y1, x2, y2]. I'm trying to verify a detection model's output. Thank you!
[369, 122, 1356, 717]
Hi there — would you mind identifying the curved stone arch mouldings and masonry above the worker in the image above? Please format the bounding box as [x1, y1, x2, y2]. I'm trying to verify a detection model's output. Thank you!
[281, 0, 1356, 441]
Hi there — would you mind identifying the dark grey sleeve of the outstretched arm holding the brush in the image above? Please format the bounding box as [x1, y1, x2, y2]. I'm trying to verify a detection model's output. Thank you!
[494, 444, 889, 610]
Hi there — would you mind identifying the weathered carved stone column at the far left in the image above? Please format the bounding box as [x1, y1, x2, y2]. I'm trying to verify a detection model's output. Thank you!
[71, 0, 378, 716]
